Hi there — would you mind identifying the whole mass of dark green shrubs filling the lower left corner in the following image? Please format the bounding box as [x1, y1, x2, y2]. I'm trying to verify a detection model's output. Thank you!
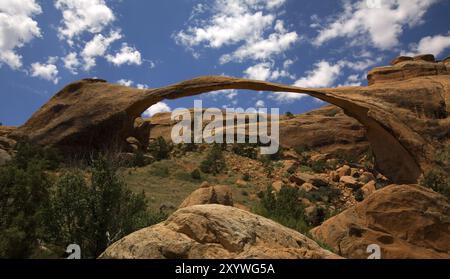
[0, 142, 165, 258]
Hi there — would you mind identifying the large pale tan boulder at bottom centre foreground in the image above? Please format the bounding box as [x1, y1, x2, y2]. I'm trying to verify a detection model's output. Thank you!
[100, 205, 339, 259]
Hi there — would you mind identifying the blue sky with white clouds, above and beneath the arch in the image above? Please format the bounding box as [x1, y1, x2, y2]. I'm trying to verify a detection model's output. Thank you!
[0, 0, 450, 125]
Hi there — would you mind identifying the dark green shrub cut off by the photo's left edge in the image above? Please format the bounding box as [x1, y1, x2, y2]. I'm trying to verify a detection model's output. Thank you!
[0, 159, 51, 258]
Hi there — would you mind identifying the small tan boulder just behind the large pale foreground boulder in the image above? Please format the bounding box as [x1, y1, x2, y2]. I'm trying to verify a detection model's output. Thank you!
[179, 185, 233, 208]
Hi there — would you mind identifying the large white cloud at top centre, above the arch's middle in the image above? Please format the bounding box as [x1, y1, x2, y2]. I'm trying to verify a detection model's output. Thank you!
[174, 0, 299, 63]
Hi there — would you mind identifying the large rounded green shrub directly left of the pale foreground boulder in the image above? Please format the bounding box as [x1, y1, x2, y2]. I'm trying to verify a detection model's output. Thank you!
[45, 158, 160, 258]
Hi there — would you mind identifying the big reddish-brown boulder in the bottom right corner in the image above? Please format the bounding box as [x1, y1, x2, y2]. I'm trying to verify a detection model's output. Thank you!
[311, 185, 450, 259]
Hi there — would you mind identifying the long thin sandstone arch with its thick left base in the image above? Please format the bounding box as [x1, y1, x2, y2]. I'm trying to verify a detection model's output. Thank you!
[15, 76, 426, 183]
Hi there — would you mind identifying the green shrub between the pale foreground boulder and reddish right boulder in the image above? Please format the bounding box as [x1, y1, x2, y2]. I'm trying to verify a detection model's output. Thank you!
[255, 186, 310, 233]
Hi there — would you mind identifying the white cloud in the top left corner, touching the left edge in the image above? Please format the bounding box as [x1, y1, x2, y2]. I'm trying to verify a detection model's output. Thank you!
[0, 0, 42, 69]
